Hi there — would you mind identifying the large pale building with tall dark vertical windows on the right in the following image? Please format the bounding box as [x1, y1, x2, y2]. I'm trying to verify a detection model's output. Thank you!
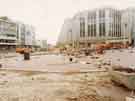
[58, 8, 131, 47]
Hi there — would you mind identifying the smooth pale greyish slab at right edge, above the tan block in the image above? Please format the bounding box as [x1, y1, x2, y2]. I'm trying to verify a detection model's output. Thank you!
[102, 48, 135, 68]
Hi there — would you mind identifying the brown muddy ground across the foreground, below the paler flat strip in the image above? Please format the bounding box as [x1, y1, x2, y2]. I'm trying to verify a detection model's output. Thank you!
[0, 70, 130, 101]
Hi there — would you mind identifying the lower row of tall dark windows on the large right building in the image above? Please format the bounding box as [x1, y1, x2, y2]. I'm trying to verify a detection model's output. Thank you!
[80, 23, 122, 37]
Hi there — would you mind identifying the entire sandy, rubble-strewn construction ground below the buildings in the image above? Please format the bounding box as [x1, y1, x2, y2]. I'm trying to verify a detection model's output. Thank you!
[0, 44, 135, 101]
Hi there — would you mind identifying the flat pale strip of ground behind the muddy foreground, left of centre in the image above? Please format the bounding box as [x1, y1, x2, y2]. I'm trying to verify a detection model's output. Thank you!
[0, 54, 104, 72]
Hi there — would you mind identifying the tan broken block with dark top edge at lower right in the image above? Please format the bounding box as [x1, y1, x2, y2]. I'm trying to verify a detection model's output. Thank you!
[110, 66, 135, 90]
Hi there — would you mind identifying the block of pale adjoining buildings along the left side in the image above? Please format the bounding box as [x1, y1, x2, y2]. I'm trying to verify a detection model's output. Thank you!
[0, 17, 35, 51]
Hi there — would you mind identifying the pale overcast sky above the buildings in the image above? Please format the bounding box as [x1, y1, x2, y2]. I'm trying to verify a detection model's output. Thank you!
[0, 0, 135, 44]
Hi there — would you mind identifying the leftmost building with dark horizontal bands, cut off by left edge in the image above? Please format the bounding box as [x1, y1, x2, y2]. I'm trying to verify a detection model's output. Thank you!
[0, 17, 17, 50]
